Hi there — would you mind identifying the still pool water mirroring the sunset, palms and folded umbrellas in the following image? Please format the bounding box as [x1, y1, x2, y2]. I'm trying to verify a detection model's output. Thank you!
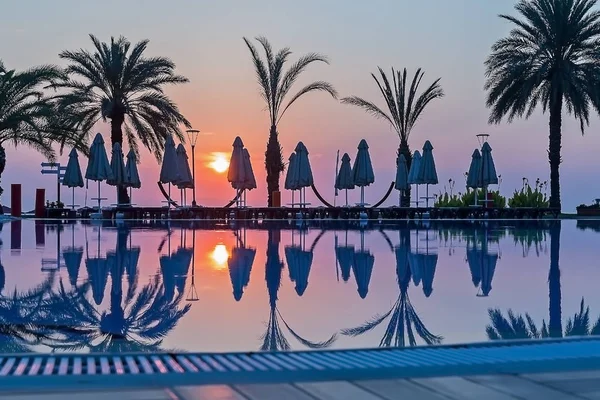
[0, 220, 600, 353]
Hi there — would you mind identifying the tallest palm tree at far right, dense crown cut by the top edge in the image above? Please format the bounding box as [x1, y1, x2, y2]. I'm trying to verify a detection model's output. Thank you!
[485, 0, 600, 209]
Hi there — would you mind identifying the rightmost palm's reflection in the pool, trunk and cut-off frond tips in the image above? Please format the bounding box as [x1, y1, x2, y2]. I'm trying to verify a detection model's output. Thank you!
[486, 221, 600, 340]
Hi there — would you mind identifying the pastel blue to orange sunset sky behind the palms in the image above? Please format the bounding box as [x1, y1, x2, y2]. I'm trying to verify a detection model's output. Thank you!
[0, 0, 600, 211]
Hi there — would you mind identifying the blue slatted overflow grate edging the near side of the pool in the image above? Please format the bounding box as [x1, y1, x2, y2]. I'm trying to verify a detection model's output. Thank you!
[0, 338, 600, 391]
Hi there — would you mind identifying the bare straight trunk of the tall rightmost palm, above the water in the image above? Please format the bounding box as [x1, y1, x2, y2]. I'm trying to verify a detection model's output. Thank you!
[548, 93, 563, 210]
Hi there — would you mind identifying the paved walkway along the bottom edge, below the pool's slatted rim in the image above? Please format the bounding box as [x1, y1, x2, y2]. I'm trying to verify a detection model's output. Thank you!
[0, 369, 600, 400]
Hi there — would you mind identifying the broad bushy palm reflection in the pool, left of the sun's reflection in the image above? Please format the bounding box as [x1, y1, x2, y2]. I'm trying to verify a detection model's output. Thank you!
[48, 228, 190, 352]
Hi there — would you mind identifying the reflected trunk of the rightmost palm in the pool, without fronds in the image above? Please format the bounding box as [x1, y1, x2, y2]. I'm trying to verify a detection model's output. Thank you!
[548, 220, 562, 337]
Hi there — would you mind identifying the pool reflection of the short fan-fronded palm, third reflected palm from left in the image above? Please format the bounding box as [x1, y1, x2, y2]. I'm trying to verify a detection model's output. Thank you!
[342, 230, 442, 347]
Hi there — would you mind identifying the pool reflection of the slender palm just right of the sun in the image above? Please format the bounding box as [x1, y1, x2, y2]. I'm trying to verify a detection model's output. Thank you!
[260, 230, 337, 351]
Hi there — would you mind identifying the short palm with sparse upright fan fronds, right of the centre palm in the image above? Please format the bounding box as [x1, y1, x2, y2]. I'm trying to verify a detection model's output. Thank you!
[342, 68, 444, 207]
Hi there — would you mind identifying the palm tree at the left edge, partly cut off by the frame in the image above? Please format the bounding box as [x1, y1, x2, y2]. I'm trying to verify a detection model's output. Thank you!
[0, 60, 85, 208]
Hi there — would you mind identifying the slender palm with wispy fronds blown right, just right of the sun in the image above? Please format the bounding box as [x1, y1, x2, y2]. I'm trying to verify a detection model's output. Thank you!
[244, 37, 337, 206]
